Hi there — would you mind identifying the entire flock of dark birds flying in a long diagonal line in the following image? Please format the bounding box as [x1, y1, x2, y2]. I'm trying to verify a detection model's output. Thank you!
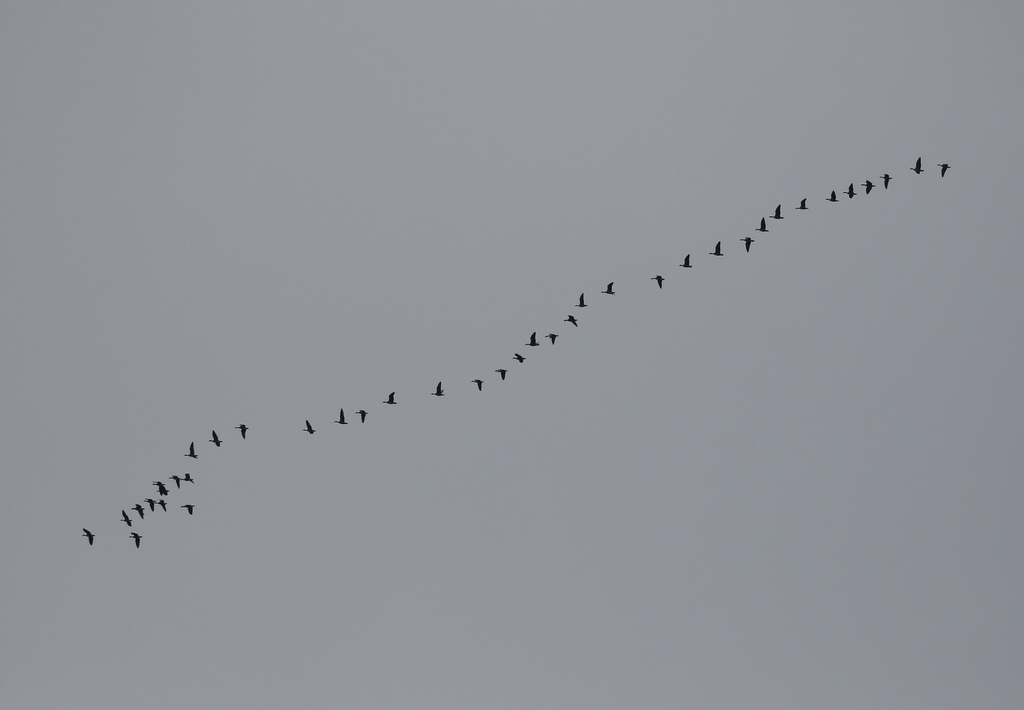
[82, 158, 950, 547]
